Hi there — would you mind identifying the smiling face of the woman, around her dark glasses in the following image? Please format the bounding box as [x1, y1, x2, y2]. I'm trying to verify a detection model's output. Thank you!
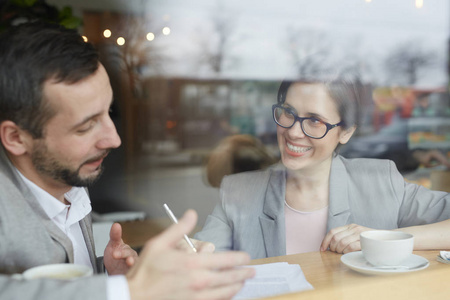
[277, 83, 354, 170]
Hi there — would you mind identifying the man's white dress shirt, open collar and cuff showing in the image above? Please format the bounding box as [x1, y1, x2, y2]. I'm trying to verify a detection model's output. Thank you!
[16, 169, 130, 300]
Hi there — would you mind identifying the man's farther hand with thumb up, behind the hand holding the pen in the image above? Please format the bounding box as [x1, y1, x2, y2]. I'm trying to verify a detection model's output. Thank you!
[103, 223, 138, 275]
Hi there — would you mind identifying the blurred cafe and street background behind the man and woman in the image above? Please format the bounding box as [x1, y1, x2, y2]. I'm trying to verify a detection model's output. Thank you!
[0, 0, 450, 232]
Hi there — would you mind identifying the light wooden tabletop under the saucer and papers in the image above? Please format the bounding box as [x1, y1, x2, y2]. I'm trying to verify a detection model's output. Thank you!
[252, 251, 450, 300]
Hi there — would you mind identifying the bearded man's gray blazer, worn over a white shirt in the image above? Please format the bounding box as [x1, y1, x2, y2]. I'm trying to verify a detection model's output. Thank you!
[0, 145, 106, 300]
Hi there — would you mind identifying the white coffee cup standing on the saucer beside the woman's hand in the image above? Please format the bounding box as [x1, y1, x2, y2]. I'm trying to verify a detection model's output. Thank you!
[360, 230, 414, 266]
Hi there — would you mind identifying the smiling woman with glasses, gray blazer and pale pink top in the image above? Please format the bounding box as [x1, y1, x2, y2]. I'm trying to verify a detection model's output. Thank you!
[196, 79, 450, 259]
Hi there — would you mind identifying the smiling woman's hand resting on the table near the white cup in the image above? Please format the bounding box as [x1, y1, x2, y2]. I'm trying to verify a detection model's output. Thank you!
[320, 224, 372, 253]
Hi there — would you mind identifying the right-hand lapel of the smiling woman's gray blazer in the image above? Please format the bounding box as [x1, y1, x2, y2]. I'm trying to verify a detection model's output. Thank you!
[327, 156, 351, 232]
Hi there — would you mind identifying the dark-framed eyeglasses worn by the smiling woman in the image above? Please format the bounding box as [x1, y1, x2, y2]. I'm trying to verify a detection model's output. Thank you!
[272, 104, 344, 139]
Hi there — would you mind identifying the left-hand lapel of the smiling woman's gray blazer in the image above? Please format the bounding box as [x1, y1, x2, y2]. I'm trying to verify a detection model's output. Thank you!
[259, 169, 286, 257]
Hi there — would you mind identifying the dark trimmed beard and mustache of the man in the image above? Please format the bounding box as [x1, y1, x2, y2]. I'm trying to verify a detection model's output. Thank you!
[31, 141, 109, 187]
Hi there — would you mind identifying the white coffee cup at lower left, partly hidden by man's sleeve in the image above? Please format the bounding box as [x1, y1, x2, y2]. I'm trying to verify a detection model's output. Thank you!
[22, 263, 93, 280]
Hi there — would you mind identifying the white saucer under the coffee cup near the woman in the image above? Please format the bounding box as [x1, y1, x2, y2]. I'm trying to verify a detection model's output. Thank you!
[341, 251, 430, 275]
